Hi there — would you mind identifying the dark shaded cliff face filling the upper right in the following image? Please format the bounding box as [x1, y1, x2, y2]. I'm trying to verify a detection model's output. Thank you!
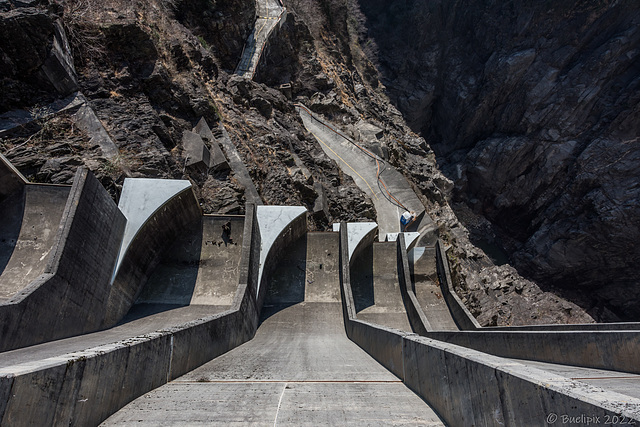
[360, 0, 640, 320]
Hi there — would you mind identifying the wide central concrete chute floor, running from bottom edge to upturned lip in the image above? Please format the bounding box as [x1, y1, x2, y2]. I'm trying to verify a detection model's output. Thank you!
[103, 233, 442, 426]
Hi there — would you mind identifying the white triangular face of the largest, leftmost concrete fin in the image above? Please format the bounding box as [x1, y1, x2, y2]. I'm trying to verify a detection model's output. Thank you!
[112, 178, 191, 280]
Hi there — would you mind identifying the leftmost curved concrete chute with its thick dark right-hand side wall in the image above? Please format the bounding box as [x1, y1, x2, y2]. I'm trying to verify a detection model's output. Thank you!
[0, 166, 124, 350]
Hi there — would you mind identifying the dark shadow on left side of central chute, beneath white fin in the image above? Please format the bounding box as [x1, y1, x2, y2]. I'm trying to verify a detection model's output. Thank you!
[260, 234, 307, 323]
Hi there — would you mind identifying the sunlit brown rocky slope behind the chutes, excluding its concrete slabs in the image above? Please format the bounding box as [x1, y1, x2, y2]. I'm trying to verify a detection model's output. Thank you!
[0, 0, 592, 325]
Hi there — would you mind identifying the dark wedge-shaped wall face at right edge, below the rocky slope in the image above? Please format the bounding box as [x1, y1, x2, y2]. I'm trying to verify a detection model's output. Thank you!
[425, 331, 640, 374]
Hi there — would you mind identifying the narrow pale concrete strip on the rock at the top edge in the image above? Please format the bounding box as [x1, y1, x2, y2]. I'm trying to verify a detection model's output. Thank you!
[236, 0, 284, 79]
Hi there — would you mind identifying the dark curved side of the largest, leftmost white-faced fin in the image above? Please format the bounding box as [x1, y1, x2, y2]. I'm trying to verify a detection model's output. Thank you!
[102, 187, 201, 327]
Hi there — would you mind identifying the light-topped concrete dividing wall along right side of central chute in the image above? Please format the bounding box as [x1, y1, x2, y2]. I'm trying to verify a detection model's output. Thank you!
[340, 227, 640, 426]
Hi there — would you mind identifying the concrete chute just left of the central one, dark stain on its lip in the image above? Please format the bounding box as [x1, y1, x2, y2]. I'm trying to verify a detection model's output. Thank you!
[0, 215, 244, 368]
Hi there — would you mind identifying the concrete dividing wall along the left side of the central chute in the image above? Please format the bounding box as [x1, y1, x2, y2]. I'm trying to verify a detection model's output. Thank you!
[0, 205, 260, 426]
